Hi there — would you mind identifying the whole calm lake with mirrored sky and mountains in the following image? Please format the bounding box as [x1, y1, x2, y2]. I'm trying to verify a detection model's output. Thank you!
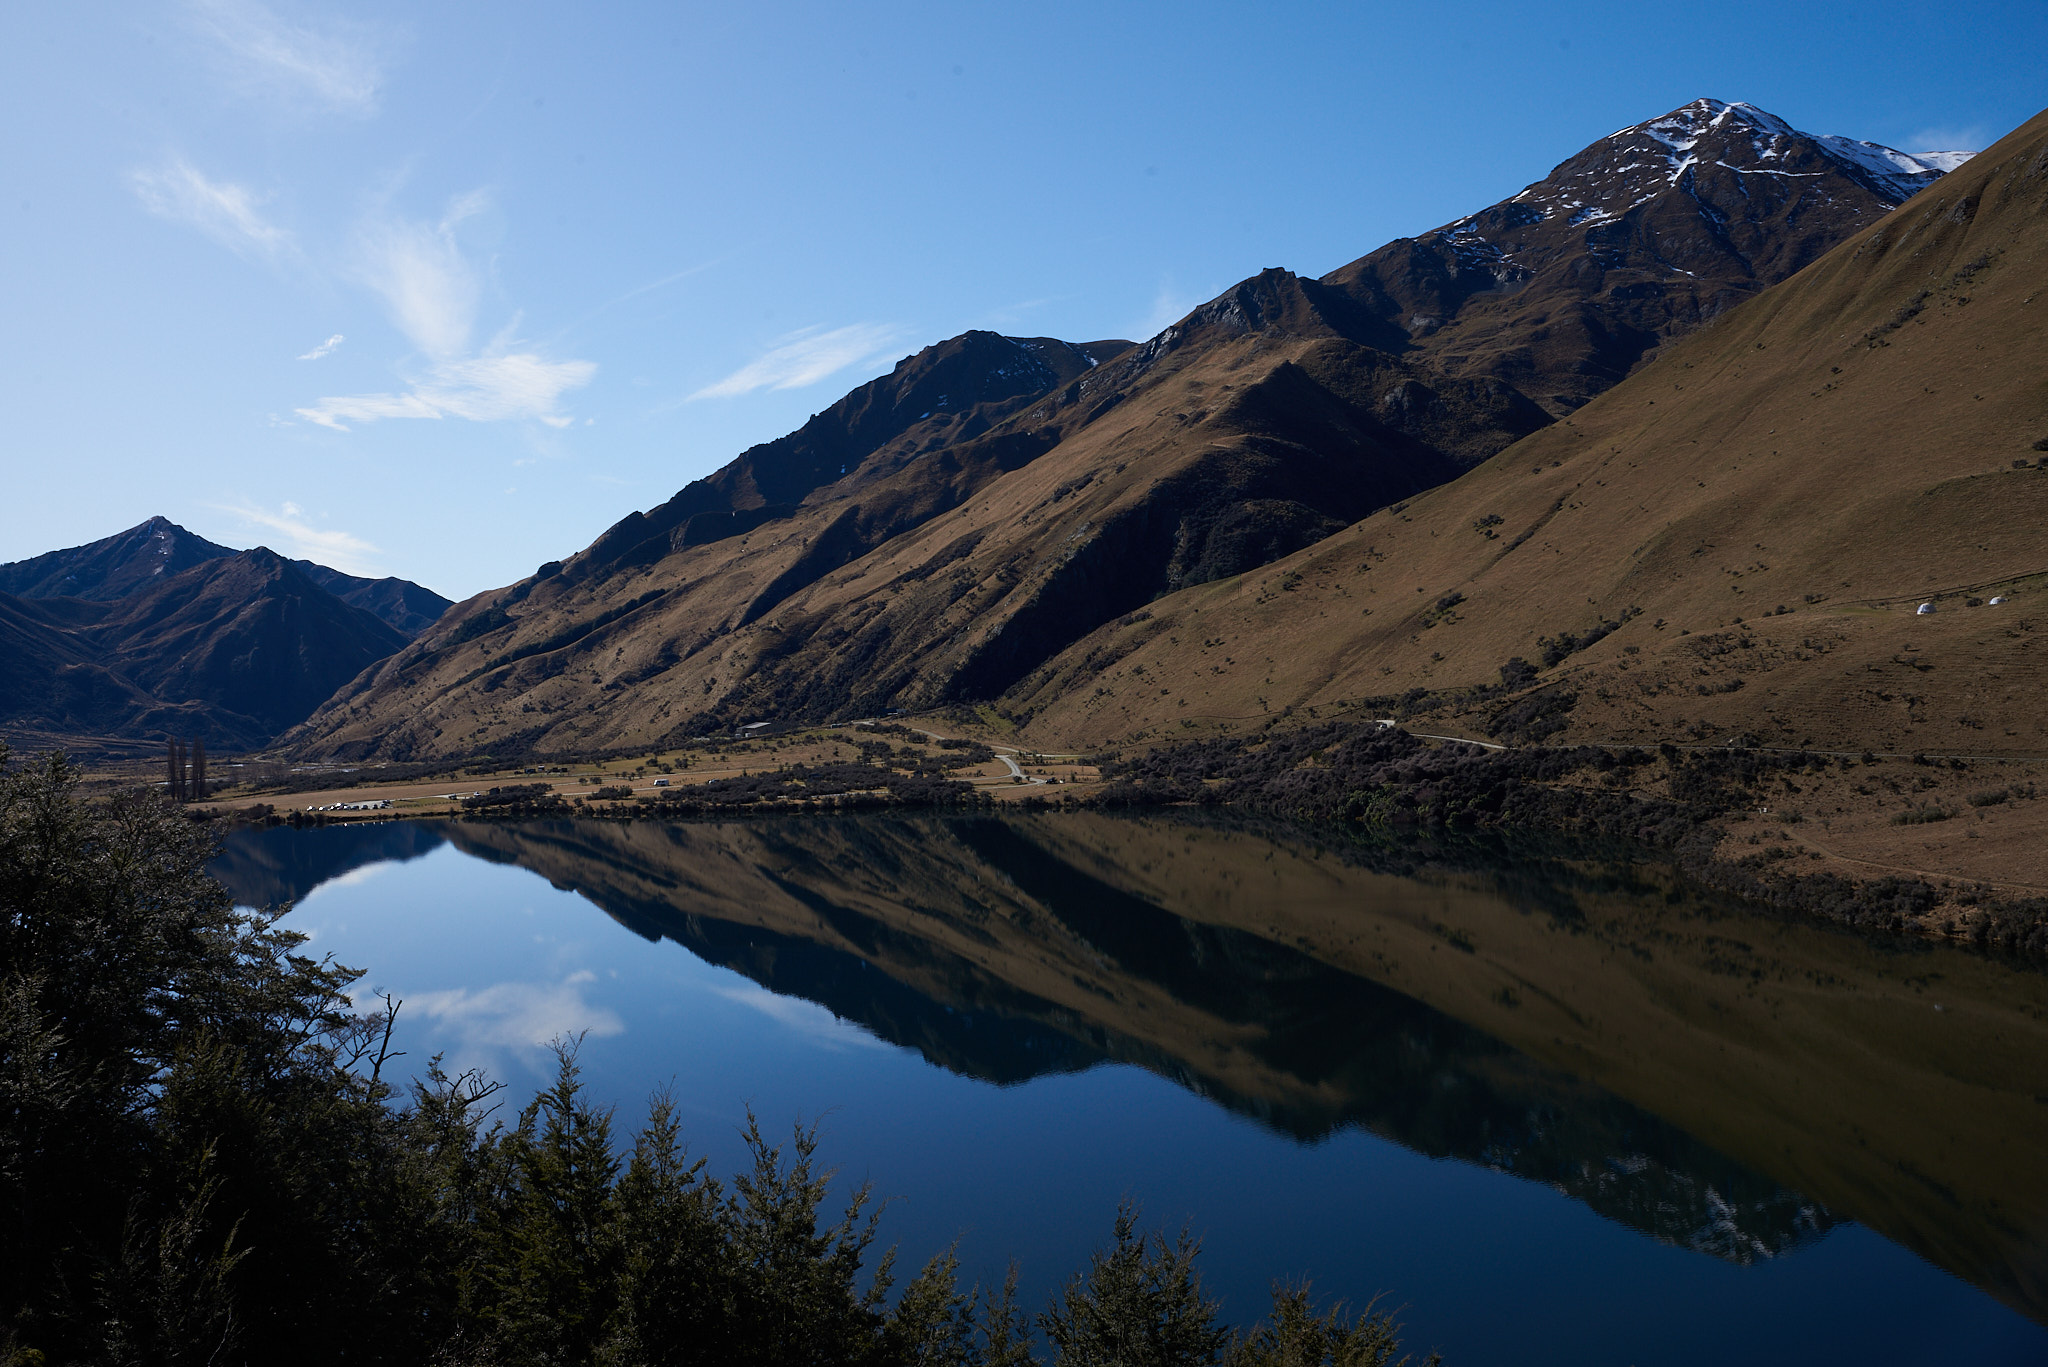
[215, 814, 2048, 1367]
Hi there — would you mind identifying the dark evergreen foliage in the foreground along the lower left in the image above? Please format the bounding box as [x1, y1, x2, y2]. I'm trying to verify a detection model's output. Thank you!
[0, 746, 1441, 1367]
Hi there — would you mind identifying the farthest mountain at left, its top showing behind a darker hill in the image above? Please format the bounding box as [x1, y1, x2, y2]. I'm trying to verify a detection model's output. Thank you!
[0, 516, 451, 639]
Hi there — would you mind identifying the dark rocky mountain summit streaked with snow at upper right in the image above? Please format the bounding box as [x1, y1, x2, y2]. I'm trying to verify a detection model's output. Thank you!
[1327, 98, 1970, 412]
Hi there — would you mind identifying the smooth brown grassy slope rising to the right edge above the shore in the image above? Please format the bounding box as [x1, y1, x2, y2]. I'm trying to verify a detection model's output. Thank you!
[1008, 115, 2048, 754]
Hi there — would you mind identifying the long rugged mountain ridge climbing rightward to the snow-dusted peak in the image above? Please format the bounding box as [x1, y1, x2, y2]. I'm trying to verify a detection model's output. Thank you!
[293, 100, 1954, 758]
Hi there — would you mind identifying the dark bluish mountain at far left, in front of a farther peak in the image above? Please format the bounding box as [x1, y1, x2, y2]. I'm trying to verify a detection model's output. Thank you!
[0, 547, 406, 750]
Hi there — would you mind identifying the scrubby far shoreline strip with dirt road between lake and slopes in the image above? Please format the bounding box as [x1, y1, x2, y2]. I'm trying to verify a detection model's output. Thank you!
[207, 723, 2048, 959]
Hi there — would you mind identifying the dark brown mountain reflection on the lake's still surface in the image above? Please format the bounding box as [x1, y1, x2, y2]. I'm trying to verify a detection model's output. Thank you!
[217, 814, 2048, 1320]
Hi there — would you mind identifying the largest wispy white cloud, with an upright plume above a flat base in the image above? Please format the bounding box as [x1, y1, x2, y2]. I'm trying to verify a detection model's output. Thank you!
[295, 191, 598, 432]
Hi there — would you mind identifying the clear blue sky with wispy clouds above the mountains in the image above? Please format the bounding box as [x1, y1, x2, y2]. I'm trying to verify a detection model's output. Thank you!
[0, 0, 2048, 598]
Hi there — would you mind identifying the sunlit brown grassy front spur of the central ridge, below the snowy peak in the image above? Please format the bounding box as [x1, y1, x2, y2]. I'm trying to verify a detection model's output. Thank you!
[297, 305, 1542, 754]
